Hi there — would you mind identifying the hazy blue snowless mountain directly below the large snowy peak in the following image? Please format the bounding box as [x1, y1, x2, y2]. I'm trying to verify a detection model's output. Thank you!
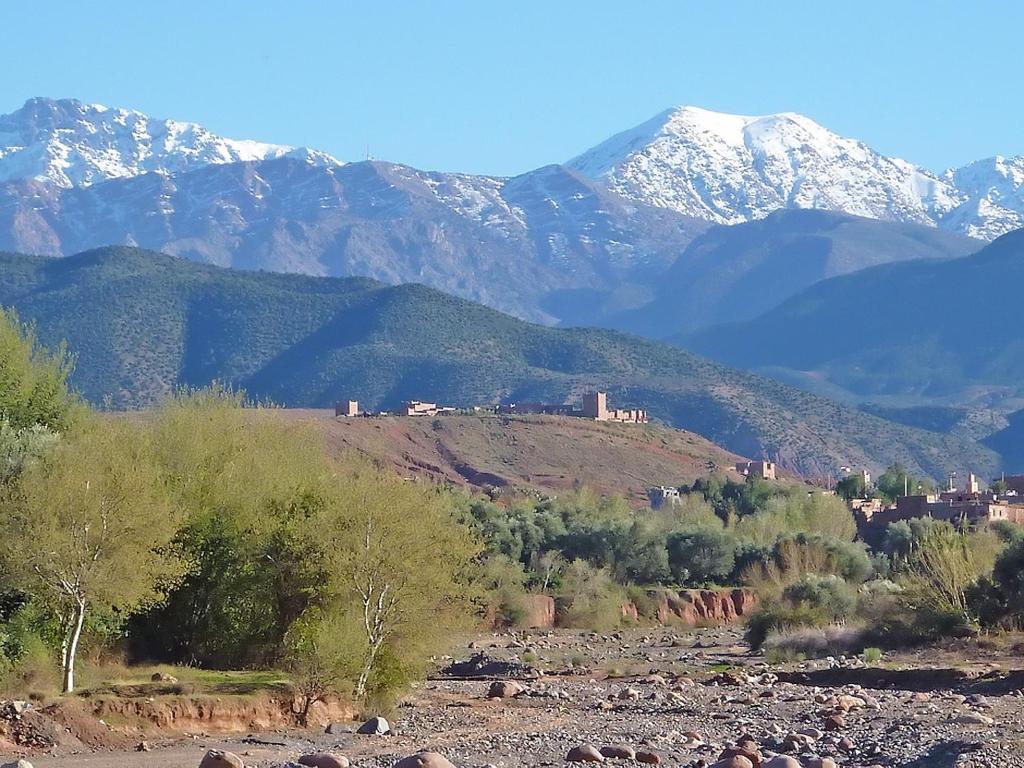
[614, 210, 984, 338]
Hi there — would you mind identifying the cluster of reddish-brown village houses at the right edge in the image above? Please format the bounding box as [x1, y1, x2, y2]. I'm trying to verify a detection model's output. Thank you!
[850, 474, 1024, 528]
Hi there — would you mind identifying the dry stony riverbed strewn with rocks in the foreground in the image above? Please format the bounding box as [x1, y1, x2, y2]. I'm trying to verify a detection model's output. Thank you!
[0, 628, 1024, 768]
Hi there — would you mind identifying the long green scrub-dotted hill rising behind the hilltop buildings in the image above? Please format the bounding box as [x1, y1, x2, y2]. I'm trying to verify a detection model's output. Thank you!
[0, 248, 998, 476]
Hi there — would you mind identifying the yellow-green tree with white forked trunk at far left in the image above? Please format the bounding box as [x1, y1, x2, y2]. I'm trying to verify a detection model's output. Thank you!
[0, 420, 179, 691]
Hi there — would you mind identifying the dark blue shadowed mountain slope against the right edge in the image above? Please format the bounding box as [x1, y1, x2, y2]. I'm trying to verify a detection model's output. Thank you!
[680, 230, 1024, 401]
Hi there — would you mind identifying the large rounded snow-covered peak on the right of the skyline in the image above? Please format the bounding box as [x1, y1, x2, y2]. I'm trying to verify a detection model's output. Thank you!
[568, 106, 1024, 240]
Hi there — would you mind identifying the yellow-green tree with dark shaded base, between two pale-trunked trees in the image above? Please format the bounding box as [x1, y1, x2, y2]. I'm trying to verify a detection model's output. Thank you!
[129, 387, 331, 667]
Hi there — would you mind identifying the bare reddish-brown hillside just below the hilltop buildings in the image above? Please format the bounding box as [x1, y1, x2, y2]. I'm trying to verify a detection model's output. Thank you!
[285, 409, 738, 504]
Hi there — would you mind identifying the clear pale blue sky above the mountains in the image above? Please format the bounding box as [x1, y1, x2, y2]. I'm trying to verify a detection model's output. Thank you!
[0, 0, 1024, 174]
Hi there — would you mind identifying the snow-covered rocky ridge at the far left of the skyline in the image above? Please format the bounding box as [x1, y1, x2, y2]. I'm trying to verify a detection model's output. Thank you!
[0, 98, 340, 187]
